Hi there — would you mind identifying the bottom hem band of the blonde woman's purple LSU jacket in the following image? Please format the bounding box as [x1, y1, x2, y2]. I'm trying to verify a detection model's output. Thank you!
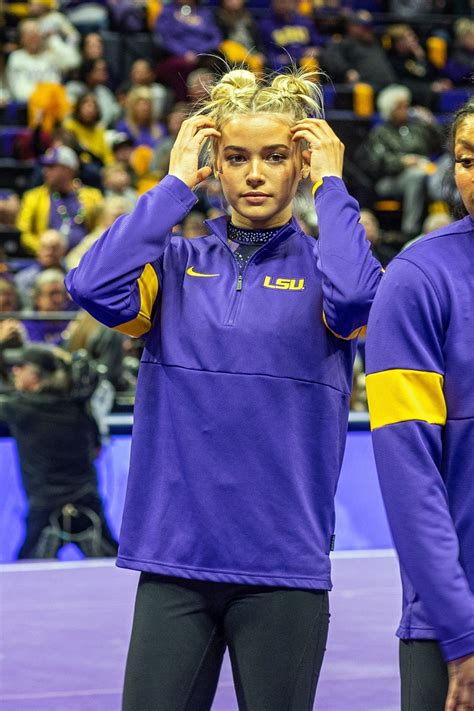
[116, 555, 332, 590]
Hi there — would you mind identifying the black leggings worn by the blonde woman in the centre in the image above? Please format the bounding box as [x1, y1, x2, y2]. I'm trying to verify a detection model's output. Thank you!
[122, 573, 329, 711]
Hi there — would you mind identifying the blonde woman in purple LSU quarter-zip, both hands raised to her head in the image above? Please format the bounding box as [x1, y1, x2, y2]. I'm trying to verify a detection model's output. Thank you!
[67, 70, 381, 711]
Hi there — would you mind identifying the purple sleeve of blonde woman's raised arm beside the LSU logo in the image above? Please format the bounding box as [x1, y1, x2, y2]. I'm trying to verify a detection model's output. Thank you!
[316, 177, 382, 338]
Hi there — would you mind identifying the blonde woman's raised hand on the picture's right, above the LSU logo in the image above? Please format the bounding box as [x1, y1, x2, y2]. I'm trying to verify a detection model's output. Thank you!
[290, 118, 344, 183]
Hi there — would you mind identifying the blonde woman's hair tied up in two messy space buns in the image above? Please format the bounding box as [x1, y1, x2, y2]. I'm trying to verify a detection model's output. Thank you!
[193, 67, 324, 156]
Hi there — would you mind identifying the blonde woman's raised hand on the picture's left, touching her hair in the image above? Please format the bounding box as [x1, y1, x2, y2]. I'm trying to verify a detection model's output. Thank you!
[168, 116, 221, 189]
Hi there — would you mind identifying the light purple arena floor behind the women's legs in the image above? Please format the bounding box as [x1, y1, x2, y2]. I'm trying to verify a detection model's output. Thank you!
[0, 551, 401, 711]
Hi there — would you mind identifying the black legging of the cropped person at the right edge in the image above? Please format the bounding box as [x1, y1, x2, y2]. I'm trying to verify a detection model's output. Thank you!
[400, 640, 448, 711]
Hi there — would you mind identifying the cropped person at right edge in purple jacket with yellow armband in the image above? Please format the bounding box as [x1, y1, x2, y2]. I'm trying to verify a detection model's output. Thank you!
[366, 99, 474, 711]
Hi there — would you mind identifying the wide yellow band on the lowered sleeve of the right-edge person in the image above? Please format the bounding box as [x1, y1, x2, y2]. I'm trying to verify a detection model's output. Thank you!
[366, 368, 447, 430]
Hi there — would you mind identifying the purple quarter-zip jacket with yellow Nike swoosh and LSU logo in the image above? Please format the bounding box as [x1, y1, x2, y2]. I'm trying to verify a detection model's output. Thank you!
[66, 176, 380, 589]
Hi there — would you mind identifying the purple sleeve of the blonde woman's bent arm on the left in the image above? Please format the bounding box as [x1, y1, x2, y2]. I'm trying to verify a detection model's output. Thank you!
[66, 175, 196, 326]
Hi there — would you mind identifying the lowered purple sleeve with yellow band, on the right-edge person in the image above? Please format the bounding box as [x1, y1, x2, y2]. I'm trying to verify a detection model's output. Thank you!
[366, 257, 474, 661]
